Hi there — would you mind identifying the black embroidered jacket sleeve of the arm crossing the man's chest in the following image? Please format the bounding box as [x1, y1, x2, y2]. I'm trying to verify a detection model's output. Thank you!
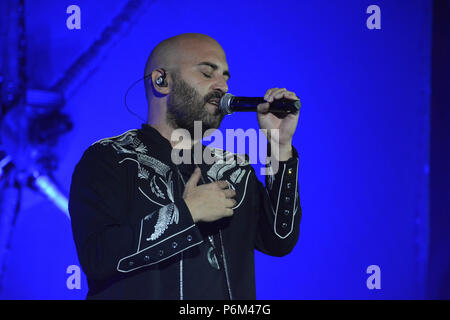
[69, 144, 203, 280]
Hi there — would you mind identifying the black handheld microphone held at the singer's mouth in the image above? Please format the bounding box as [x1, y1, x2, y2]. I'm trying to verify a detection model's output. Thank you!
[219, 93, 300, 114]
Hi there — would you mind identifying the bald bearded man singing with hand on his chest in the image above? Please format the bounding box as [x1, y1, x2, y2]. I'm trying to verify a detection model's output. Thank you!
[69, 33, 301, 300]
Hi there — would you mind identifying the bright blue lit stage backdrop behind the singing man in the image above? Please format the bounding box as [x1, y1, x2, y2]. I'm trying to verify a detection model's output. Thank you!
[0, 0, 431, 299]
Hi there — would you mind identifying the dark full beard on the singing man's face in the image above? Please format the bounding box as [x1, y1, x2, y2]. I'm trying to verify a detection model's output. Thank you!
[167, 72, 225, 137]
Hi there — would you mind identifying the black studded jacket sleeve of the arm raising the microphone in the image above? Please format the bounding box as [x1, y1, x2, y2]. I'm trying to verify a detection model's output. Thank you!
[255, 147, 302, 256]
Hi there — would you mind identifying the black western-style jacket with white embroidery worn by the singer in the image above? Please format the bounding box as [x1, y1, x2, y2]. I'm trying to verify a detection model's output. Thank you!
[69, 124, 301, 299]
